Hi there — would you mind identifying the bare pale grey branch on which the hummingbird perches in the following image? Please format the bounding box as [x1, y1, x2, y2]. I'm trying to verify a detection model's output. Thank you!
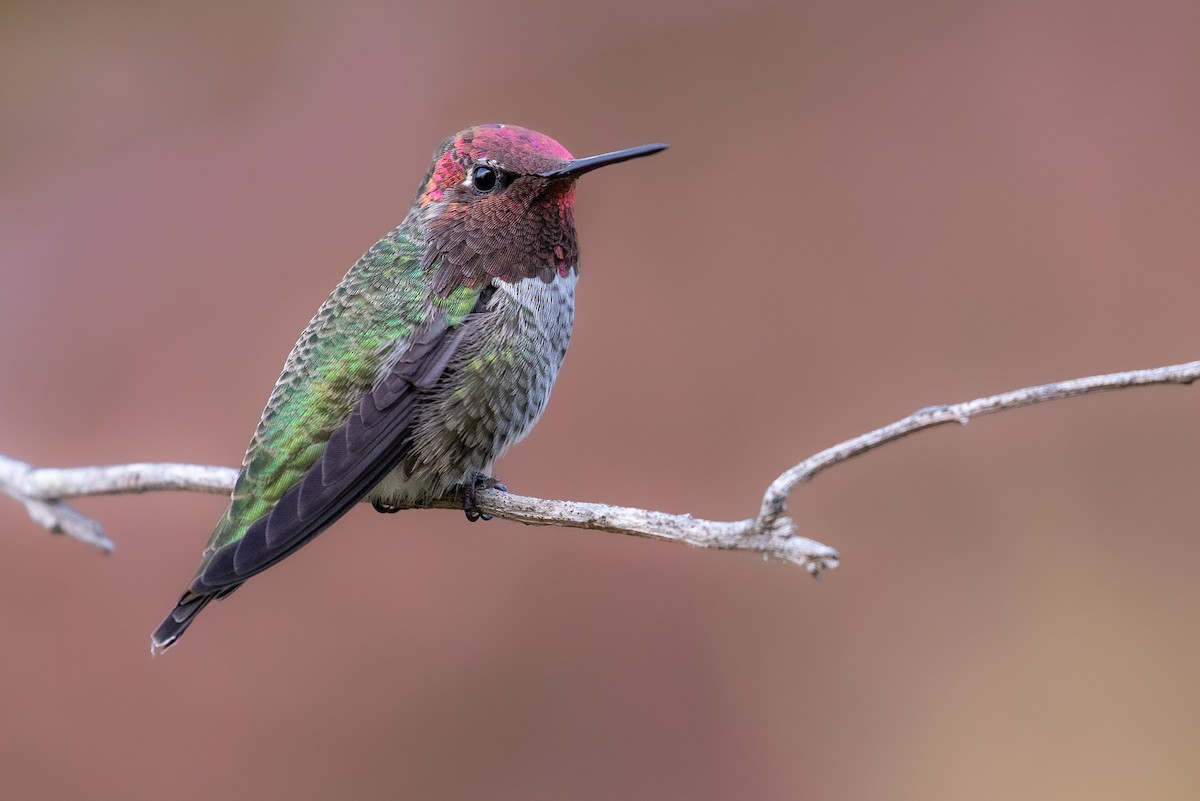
[0, 361, 1200, 578]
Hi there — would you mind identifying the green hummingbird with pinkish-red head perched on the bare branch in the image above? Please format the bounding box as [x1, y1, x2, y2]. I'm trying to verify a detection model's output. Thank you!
[150, 124, 666, 654]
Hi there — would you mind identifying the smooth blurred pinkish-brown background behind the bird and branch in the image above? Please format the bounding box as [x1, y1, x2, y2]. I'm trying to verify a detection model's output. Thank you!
[0, 0, 1200, 801]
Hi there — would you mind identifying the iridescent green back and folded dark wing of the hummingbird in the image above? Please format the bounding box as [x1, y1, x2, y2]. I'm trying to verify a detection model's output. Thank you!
[192, 230, 484, 592]
